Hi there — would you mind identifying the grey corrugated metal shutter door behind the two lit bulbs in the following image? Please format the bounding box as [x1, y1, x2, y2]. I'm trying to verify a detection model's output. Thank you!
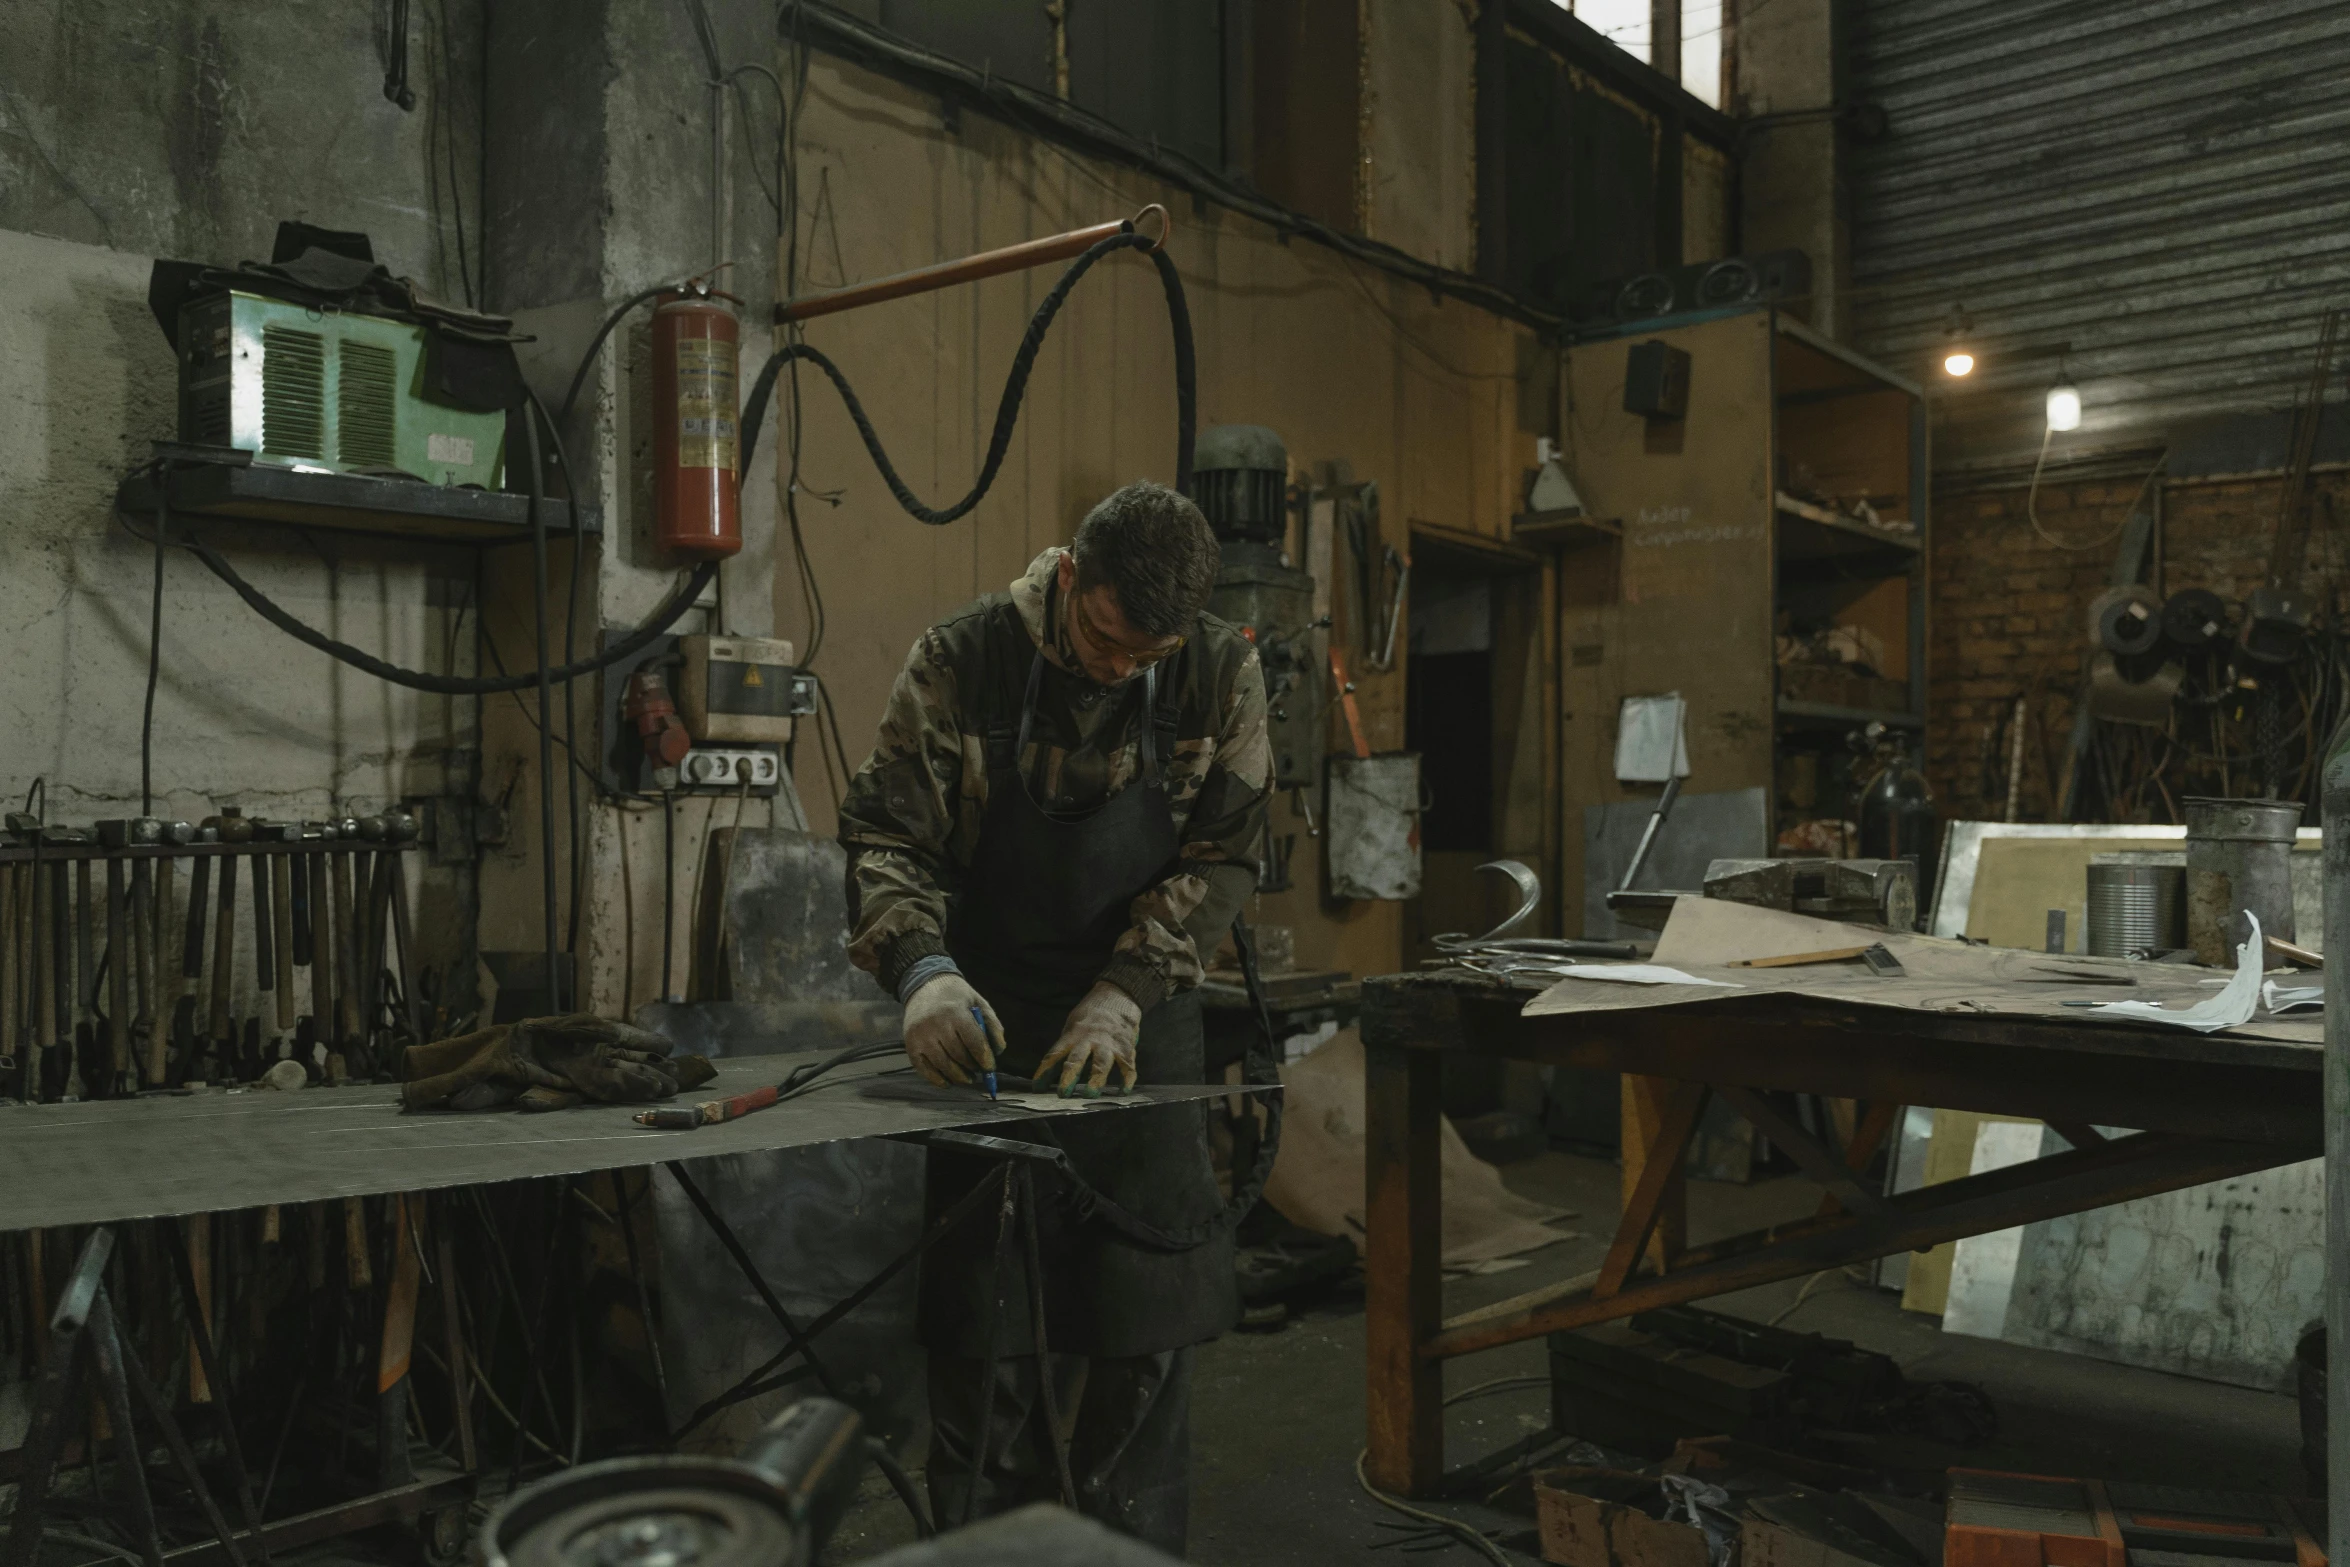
[1847, 0, 2350, 472]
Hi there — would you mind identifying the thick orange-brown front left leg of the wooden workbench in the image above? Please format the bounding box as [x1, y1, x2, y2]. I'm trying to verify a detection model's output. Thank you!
[1363, 1045, 1445, 1497]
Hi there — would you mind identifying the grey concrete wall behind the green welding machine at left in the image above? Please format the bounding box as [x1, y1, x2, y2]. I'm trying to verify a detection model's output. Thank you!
[0, 0, 479, 1019]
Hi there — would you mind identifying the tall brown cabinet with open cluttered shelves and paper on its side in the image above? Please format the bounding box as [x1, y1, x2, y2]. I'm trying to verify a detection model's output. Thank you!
[1558, 305, 1929, 935]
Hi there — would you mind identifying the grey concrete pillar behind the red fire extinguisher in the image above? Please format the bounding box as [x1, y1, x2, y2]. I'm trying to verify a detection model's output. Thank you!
[482, 0, 797, 1013]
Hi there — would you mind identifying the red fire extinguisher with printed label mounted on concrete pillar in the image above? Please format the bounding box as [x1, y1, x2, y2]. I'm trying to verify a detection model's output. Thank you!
[653, 291, 743, 559]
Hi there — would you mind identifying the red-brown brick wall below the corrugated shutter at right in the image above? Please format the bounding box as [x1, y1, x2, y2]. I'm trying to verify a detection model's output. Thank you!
[1927, 475, 2350, 822]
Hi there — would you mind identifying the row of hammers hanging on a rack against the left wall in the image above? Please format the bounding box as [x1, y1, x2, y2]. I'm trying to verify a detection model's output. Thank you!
[0, 806, 423, 1102]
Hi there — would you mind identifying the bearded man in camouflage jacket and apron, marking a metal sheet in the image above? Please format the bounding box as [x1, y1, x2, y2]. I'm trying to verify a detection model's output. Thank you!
[841, 484, 1271, 1553]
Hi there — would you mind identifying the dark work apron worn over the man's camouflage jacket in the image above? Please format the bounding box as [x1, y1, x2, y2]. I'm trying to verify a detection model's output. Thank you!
[921, 604, 1241, 1356]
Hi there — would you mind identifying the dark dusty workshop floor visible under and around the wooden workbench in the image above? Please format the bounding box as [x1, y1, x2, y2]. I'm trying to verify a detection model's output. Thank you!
[825, 1154, 2301, 1567]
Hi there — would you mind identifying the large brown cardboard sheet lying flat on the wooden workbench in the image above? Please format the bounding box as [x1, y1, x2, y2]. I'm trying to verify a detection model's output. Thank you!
[1525, 893, 2324, 1052]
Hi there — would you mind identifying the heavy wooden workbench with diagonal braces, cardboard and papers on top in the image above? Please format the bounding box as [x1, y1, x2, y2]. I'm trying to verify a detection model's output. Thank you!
[1363, 970, 2324, 1497]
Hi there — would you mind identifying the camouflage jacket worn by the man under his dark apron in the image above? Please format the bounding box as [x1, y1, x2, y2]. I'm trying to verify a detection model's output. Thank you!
[841, 547, 1271, 1008]
